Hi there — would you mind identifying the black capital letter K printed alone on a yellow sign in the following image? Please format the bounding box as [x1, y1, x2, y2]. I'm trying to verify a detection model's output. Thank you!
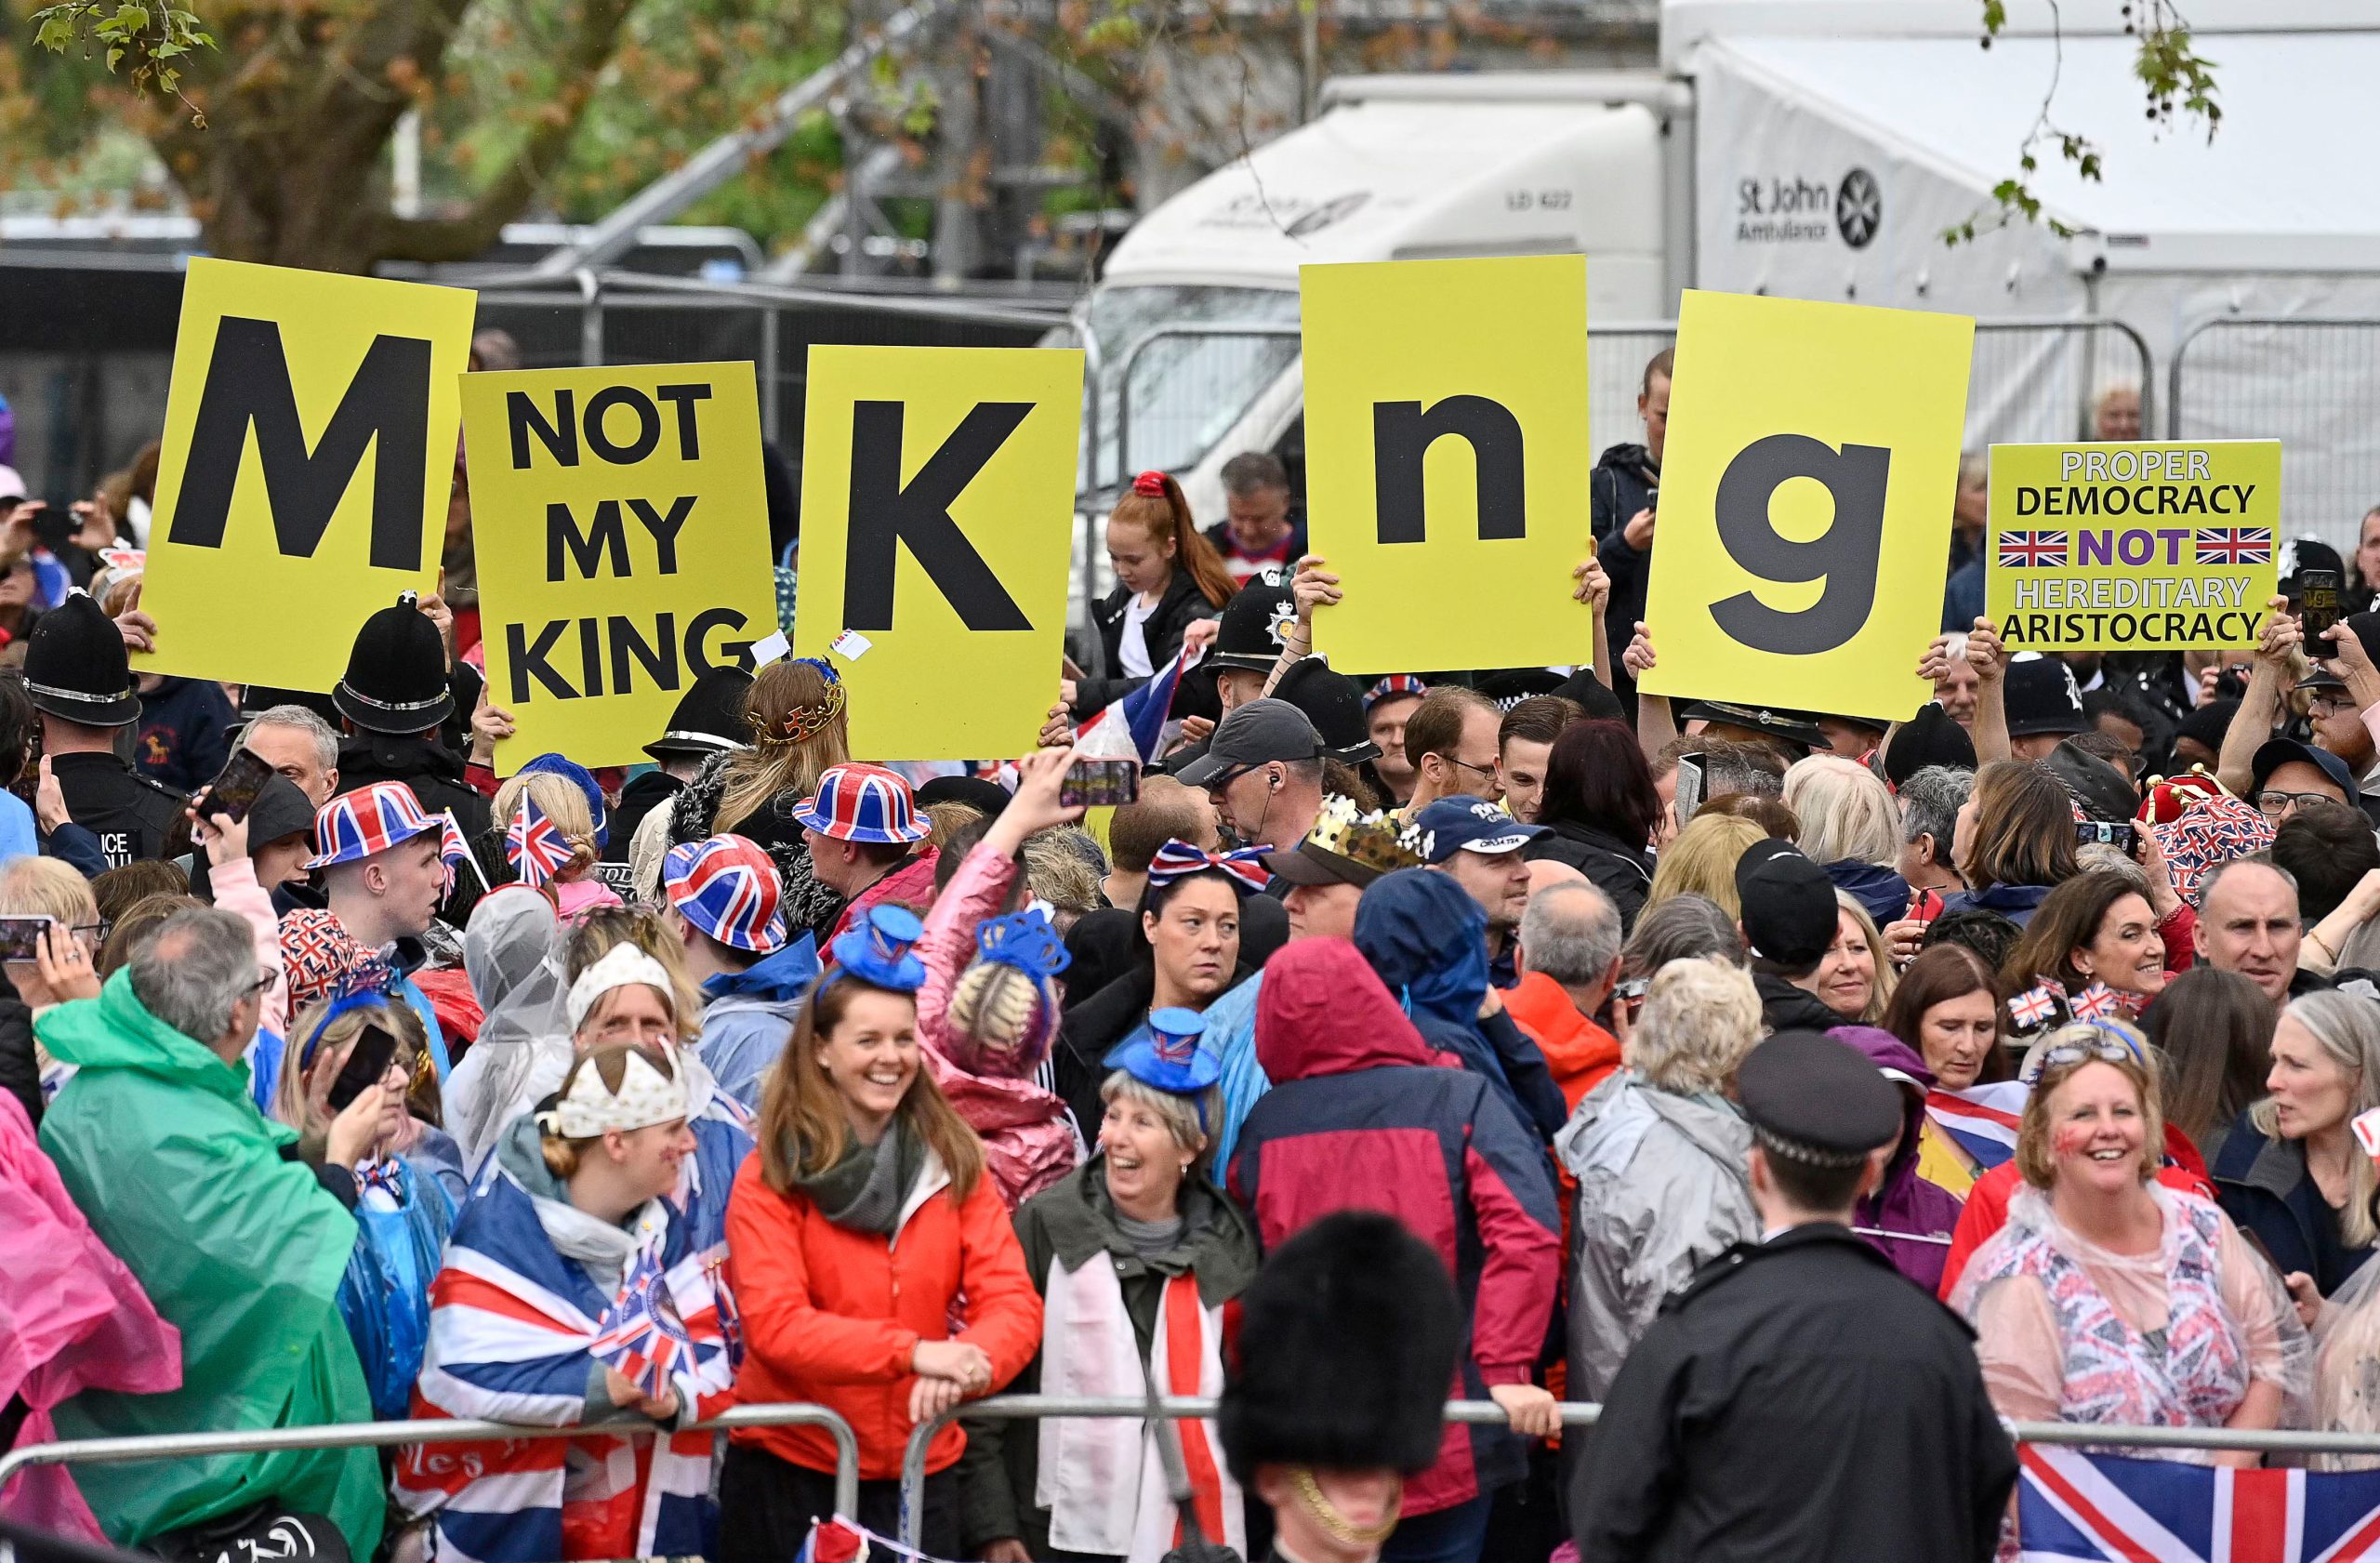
[842, 402, 1033, 633]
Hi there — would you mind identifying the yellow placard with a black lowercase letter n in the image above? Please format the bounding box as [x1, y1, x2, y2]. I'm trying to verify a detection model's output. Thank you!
[1297, 255, 1594, 673]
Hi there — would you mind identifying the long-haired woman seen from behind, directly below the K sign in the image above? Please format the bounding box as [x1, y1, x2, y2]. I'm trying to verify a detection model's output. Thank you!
[652, 656, 852, 940]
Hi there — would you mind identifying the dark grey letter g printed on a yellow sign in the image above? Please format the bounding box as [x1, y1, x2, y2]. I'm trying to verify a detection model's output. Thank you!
[1712, 433, 1892, 656]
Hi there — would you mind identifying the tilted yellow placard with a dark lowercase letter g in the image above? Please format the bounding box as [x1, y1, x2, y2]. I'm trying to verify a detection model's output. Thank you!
[1640, 293, 1976, 721]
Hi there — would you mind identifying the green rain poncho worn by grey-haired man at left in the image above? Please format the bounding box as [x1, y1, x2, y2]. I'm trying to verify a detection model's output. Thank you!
[33, 971, 383, 1558]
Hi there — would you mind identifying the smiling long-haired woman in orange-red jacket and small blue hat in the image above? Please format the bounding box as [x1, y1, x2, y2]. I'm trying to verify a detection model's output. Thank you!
[717, 907, 1042, 1563]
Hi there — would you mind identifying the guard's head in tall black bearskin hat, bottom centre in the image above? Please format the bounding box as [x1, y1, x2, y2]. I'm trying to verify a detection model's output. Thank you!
[1227, 1211, 1466, 1563]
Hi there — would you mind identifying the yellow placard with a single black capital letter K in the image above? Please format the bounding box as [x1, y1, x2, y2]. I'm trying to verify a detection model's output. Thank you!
[792, 348, 1083, 759]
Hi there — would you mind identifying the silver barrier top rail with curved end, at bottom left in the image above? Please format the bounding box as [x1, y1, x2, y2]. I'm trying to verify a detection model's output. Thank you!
[0, 1404, 866, 1513]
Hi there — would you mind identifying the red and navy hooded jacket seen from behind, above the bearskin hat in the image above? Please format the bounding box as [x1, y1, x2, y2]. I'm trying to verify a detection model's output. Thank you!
[1231, 940, 1561, 1516]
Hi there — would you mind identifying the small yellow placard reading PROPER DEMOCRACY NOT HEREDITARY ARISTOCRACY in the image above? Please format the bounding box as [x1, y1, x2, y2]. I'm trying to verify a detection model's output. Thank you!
[1985, 440, 2280, 652]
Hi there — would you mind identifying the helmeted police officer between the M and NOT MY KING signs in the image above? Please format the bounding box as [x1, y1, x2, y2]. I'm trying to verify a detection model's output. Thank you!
[331, 592, 488, 842]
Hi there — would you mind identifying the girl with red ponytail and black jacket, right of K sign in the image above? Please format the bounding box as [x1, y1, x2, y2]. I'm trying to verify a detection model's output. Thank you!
[1059, 471, 1233, 721]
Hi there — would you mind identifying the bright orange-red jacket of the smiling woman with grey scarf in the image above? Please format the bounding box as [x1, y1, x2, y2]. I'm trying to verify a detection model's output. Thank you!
[728, 1156, 1040, 1482]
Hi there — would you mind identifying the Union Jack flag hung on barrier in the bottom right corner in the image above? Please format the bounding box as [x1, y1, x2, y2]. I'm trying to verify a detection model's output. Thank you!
[2016, 1444, 2380, 1563]
